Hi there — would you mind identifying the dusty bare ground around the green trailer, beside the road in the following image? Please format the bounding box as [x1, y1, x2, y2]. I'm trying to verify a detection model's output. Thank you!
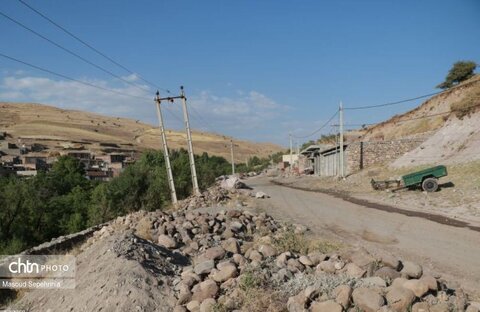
[273, 161, 480, 227]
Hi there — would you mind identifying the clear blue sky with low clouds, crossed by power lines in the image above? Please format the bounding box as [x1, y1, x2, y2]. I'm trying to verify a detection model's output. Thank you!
[0, 0, 480, 145]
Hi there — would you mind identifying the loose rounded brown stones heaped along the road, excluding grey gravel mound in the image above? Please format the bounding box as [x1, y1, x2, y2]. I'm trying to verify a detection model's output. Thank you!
[109, 210, 480, 312]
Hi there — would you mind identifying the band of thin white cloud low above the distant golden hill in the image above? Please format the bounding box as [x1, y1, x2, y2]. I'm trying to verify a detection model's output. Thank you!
[0, 74, 291, 144]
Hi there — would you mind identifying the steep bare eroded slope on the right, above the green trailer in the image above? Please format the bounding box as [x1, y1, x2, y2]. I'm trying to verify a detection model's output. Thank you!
[356, 75, 480, 167]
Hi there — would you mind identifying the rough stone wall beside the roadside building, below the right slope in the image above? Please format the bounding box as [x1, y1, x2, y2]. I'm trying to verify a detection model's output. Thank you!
[346, 136, 427, 173]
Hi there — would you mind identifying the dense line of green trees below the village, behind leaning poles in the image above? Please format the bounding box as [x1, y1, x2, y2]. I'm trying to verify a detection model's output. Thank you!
[0, 149, 278, 254]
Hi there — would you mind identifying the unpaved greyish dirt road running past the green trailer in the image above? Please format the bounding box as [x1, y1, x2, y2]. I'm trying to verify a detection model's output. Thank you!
[248, 177, 480, 298]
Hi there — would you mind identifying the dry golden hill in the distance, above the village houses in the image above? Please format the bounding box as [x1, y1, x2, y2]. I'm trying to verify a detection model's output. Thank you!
[0, 102, 282, 162]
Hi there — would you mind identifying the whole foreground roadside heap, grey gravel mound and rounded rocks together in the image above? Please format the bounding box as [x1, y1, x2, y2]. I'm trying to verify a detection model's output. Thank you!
[8, 177, 480, 312]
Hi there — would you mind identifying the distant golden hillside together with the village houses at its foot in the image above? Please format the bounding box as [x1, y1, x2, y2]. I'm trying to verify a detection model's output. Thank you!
[0, 103, 282, 181]
